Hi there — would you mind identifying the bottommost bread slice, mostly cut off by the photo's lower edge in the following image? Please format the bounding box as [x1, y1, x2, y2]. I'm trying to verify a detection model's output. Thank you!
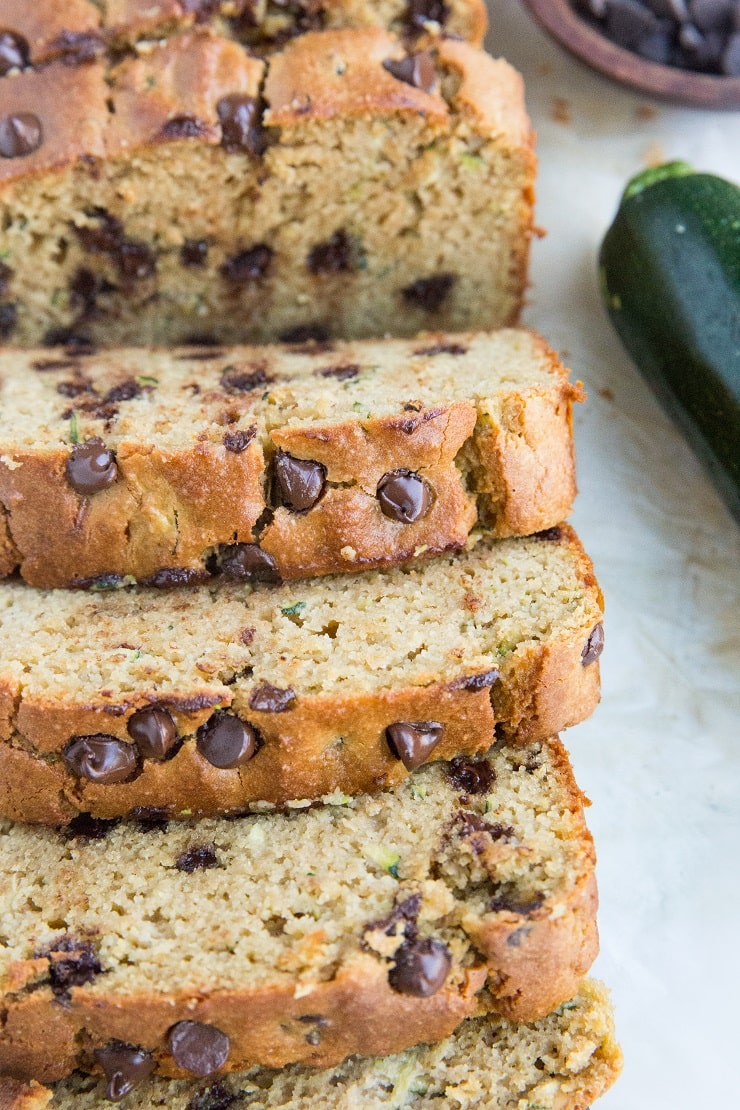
[0, 980, 621, 1110]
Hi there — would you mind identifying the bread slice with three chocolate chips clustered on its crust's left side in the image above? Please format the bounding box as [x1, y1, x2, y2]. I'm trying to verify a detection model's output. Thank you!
[0, 526, 602, 825]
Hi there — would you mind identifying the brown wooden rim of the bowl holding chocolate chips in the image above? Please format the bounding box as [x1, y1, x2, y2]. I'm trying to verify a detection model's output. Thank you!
[523, 0, 740, 109]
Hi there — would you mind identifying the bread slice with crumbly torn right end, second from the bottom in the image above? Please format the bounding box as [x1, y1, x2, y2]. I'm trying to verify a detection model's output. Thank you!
[0, 740, 597, 1081]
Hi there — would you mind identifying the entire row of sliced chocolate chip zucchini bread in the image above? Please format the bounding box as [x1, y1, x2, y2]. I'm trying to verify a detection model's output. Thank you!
[0, 0, 620, 1110]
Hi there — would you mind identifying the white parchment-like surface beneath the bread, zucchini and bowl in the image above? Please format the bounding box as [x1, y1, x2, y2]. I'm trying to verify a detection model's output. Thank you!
[487, 0, 740, 1110]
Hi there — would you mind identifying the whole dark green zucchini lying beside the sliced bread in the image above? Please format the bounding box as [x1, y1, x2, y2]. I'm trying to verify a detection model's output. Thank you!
[599, 162, 740, 522]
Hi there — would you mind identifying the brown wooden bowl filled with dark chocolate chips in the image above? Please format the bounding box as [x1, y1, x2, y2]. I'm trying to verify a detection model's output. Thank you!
[524, 0, 740, 109]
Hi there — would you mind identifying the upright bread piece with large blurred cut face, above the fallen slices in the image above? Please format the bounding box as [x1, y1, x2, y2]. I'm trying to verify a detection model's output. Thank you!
[0, 28, 535, 347]
